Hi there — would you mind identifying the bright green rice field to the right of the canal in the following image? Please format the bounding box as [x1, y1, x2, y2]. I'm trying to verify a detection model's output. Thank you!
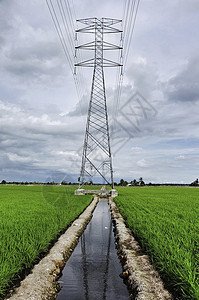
[115, 187, 199, 300]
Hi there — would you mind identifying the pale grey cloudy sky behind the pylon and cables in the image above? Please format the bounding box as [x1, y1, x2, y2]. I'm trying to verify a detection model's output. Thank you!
[0, 0, 199, 183]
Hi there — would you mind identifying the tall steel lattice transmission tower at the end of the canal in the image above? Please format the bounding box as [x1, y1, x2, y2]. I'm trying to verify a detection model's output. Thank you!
[75, 18, 122, 188]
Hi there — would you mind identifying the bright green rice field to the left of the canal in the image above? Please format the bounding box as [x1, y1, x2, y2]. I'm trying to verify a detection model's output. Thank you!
[0, 185, 92, 296]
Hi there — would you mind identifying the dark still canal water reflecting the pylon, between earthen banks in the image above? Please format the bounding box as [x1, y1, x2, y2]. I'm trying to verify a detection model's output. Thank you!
[57, 199, 129, 300]
